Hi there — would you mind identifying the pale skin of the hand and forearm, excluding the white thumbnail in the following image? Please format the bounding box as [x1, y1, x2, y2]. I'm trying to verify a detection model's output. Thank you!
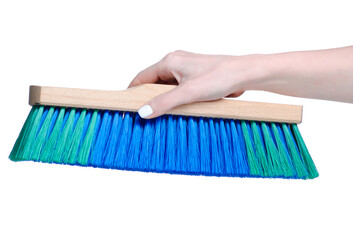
[129, 46, 353, 118]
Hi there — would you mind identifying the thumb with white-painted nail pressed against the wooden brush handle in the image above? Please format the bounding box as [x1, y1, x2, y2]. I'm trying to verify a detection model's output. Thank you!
[138, 84, 195, 119]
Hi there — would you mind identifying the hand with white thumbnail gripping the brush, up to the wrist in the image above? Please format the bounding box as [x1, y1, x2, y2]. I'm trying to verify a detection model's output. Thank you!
[129, 51, 259, 118]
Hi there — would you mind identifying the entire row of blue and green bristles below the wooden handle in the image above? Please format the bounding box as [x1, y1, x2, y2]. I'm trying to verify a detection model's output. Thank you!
[10, 106, 318, 179]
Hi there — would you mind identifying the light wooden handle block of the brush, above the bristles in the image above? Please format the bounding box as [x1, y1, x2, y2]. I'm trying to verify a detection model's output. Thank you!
[29, 84, 302, 123]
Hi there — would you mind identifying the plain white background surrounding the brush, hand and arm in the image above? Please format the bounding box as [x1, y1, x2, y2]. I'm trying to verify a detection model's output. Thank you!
[0, 0, 353, 240]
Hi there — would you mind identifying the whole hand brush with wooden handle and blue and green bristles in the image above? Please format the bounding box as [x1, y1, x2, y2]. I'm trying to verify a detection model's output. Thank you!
[9, 84, 318, 179]
